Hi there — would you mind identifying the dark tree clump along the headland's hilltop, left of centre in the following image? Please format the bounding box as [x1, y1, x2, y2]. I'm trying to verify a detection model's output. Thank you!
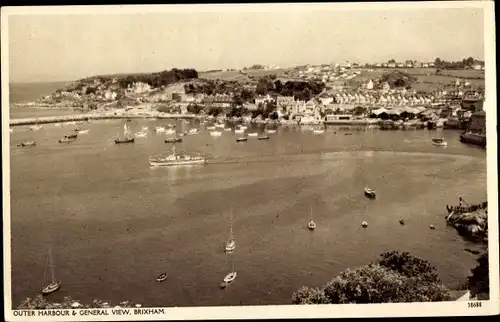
[118, 68, 198, 88]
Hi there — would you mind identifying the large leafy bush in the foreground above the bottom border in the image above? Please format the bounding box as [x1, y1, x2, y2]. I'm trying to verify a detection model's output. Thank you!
[292, 251, 451, 304]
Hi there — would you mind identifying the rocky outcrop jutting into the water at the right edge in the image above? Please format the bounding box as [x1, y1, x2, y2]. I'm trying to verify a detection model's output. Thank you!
[446, 209, 488, 242]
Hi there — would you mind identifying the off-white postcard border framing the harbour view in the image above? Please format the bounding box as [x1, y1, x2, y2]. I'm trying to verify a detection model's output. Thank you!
[1, 1, 500, 321]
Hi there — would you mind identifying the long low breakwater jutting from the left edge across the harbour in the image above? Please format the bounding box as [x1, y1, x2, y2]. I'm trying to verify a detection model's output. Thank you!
[9, 112, 198, 126]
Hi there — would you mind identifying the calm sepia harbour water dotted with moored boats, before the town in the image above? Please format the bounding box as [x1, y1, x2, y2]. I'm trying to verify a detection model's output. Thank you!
[10, 120, 486, 306]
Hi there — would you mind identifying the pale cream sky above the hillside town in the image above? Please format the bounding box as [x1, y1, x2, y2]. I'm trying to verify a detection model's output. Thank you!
[8, 6, 484, 82]
